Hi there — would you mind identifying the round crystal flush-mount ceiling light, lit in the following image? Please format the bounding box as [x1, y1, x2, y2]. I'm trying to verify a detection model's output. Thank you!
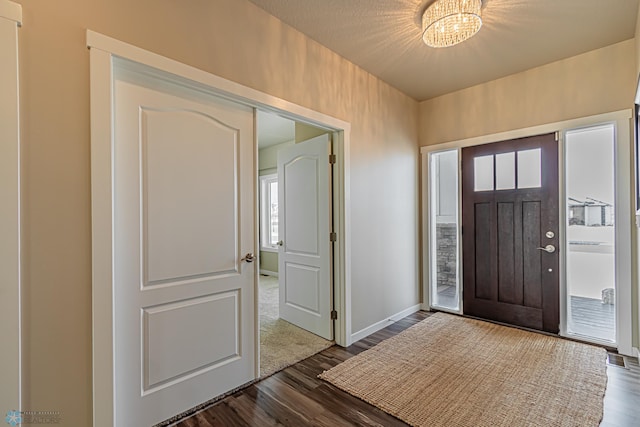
[422, 0, 482, 47]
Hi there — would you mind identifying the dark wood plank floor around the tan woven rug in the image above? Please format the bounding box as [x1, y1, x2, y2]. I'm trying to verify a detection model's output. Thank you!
[176, 311, 640, 427]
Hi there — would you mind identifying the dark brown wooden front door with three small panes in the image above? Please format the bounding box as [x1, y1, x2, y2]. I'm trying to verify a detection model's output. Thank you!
[462, 134, 560, 333]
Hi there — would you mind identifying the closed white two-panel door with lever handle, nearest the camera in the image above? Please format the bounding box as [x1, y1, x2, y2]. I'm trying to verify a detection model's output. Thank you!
[114, 76, 256, 426]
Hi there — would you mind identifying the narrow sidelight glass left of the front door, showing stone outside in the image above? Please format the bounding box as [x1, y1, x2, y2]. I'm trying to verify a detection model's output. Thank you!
[429, 150, 460, 311]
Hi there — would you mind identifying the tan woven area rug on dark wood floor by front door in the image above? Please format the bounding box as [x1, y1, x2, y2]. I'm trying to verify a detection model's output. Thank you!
[319, 313, 607, 427]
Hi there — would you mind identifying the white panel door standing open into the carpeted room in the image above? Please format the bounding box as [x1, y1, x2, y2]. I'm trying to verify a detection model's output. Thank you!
[278, 135, 333, 340]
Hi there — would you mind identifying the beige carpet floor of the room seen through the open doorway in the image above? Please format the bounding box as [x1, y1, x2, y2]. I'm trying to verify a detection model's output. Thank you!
[259, 276, 333, 378]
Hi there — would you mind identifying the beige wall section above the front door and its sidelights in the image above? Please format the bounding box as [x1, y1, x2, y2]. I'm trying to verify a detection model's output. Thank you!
[419, 39, 636, 145]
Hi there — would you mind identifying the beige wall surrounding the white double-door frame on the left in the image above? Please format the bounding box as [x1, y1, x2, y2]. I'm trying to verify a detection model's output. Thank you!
[18, 0, 418, 427]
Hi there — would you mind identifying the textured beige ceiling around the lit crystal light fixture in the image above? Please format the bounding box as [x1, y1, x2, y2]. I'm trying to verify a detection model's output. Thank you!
[250, 0, 640, 100]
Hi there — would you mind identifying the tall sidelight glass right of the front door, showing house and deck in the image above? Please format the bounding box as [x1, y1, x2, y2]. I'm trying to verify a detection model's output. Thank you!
[566, 125, 616, 343]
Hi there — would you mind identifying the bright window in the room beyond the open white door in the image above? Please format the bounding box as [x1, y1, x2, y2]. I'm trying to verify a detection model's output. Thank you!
[260, 174, 278, 252]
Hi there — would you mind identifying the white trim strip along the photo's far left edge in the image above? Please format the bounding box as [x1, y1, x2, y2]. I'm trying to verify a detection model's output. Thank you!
[0, 0, 22, 417]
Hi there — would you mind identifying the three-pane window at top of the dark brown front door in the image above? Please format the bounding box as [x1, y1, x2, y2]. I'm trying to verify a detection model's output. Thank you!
[473, 148, 542, 191]
